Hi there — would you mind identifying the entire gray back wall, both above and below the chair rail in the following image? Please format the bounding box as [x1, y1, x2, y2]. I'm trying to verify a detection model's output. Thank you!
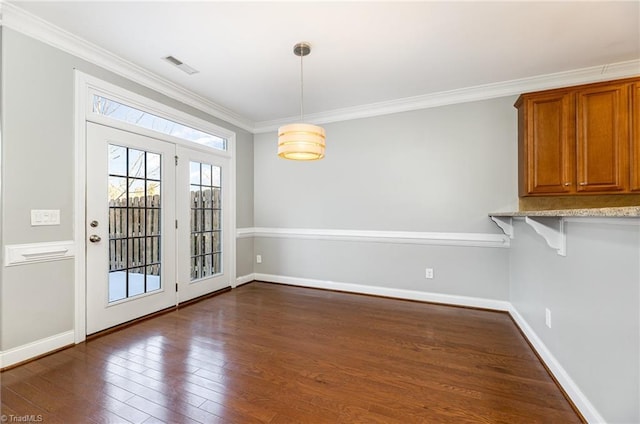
[254, 97, 517, 300]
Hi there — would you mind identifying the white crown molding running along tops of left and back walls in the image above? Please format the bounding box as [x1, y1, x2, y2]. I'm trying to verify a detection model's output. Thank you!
[0, 0, 640, 133]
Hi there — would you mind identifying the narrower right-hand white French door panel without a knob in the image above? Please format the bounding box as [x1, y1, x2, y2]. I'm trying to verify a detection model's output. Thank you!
[176, 146, 232, 302]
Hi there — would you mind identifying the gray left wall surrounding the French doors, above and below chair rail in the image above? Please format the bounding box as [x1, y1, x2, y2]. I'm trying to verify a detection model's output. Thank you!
[0, 28, 253, 350]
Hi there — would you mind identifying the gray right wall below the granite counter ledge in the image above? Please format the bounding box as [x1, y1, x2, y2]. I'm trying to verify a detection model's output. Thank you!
[510, 220, 640, 423]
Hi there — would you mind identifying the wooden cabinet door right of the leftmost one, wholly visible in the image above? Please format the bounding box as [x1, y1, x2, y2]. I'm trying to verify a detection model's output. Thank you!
[576, 84, 629, 192]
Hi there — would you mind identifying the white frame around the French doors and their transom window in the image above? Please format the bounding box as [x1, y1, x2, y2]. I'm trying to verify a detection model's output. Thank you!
[73, 69, 236, 343]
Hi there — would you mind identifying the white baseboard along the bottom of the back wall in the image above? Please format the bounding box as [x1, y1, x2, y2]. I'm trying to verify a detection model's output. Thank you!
[254, 273, 511, 311]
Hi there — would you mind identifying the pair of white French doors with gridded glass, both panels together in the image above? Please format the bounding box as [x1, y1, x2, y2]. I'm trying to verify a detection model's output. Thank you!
[86, 122, 231, 334]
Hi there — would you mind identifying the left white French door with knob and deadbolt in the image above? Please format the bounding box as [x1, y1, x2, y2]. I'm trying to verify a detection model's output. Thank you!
[86, 122, 177, 334]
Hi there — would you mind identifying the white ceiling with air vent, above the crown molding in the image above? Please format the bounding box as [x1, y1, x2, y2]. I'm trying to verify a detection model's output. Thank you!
[6, 1, 640, 126]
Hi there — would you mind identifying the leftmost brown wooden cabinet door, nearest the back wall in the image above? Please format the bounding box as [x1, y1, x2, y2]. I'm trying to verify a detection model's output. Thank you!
[519, 92, 576, 195]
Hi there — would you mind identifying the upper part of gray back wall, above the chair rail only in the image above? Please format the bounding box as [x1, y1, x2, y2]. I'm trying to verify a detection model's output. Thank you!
[254, 97, 517, 233]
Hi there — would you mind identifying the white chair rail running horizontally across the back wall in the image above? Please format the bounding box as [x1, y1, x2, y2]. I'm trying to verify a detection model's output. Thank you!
[236, 227, 511, 248]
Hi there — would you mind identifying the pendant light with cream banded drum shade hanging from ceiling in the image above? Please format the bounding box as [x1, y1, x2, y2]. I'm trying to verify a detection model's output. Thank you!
[278, 42, 325, 161]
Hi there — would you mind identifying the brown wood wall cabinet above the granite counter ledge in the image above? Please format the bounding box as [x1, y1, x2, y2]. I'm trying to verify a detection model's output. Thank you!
[515, 78, 640, 196]
